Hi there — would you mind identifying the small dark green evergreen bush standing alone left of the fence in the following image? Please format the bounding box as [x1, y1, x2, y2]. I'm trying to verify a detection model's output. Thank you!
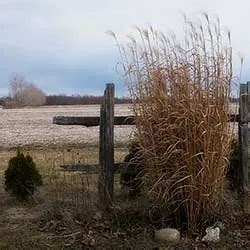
[5, 152, 42, 201]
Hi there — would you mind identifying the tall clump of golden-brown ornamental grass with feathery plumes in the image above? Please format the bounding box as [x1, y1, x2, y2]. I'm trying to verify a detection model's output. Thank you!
[111, 14, 232, 231]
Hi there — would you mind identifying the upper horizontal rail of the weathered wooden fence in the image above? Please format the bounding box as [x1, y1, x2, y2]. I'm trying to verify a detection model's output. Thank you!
[53, 114, 239, 127]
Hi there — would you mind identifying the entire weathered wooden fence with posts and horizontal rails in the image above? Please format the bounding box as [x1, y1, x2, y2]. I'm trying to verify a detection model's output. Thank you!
[56, 82, 250, 213]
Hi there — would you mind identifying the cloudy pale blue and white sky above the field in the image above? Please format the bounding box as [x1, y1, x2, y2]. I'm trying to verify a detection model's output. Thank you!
[0, 0, 250, 96]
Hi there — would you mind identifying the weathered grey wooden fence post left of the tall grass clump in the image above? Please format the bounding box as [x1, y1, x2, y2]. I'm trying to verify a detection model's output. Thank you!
[98, 84, 115, 209]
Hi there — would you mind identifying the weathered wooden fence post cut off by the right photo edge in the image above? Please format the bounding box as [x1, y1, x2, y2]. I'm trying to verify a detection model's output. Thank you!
[239, 82, 250, 213]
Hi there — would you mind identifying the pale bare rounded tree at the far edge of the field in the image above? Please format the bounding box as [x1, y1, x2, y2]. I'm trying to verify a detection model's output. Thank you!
[10, 74, 46, 106]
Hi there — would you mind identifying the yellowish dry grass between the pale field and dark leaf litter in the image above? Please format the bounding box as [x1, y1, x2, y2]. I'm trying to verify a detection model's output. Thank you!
[0, 147, 127, 218]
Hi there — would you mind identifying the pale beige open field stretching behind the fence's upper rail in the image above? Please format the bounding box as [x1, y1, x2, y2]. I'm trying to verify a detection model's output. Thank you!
[0, 105, 133, 148]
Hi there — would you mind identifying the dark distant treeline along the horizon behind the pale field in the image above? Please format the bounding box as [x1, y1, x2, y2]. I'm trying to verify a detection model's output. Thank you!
[45, 95, 131, 105]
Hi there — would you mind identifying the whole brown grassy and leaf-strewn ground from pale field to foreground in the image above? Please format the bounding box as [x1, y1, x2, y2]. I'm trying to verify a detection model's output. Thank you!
[0, 146, 250, 249]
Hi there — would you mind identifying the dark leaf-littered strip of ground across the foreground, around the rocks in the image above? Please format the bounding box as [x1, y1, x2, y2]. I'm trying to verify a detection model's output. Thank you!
[0, 172, 250, 250]
